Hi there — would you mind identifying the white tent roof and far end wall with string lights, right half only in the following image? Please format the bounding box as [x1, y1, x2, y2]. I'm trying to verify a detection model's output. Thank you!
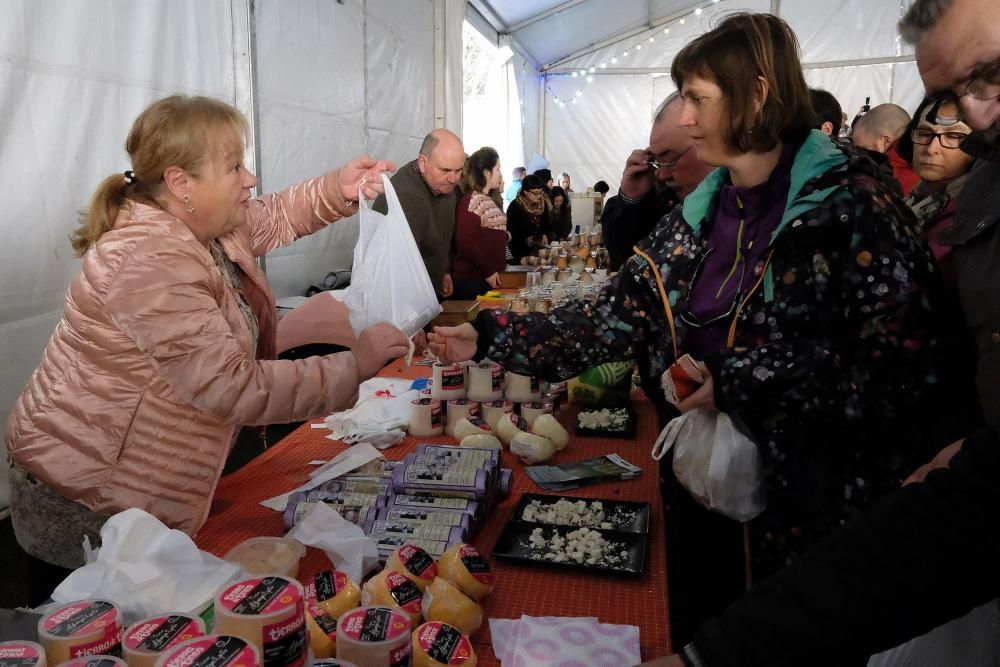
[469, 0, 923, 192]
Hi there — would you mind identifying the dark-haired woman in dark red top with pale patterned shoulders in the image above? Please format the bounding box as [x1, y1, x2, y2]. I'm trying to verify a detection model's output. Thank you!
[451, 146, 507, 299]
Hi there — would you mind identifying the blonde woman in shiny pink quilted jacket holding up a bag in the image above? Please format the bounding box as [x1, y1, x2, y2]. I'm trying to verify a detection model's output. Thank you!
[6, 95, 408, 568]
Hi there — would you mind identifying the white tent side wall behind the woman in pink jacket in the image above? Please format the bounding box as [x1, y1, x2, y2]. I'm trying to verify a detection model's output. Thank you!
[0, 0, 465, 512]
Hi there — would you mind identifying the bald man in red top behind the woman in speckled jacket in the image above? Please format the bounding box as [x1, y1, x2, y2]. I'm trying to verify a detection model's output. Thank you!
[851, 104, 920, 196]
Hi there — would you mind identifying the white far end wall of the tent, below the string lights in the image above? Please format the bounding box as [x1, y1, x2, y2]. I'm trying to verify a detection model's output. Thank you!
[544, 0, 923, 192]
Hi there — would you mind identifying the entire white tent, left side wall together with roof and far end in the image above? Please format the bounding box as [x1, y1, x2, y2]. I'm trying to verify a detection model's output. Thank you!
[0, 0, 921, 511]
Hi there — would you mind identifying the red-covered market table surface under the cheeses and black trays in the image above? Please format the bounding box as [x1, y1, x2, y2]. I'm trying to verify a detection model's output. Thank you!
[195, 363, 670, 667]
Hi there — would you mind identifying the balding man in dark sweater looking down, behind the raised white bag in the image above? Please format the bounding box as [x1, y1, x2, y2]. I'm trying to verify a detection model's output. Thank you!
[374, 128, 465, 298]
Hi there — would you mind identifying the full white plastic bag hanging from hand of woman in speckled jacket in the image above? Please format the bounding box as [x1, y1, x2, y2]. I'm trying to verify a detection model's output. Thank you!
[653, 410, 767, 521]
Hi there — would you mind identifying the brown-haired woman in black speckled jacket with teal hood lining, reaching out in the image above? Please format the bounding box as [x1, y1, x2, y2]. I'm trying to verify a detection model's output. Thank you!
[429, 14, 947, 639]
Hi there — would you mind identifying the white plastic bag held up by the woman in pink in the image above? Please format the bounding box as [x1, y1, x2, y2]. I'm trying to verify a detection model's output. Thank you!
[329, 174, 441, 338]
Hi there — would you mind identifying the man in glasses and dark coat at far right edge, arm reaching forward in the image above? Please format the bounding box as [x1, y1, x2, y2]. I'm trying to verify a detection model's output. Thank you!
[649, 0, 1000, 667]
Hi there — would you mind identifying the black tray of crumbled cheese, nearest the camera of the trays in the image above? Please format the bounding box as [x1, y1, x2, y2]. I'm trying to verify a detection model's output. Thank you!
[492, 521, 646, 576]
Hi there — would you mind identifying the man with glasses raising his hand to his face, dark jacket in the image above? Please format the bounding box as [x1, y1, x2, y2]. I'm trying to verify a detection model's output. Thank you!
[601, 92, 712, 269]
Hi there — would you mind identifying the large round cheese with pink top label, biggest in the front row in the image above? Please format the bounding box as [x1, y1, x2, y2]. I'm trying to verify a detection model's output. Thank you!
[213, 577, 308, 667]
